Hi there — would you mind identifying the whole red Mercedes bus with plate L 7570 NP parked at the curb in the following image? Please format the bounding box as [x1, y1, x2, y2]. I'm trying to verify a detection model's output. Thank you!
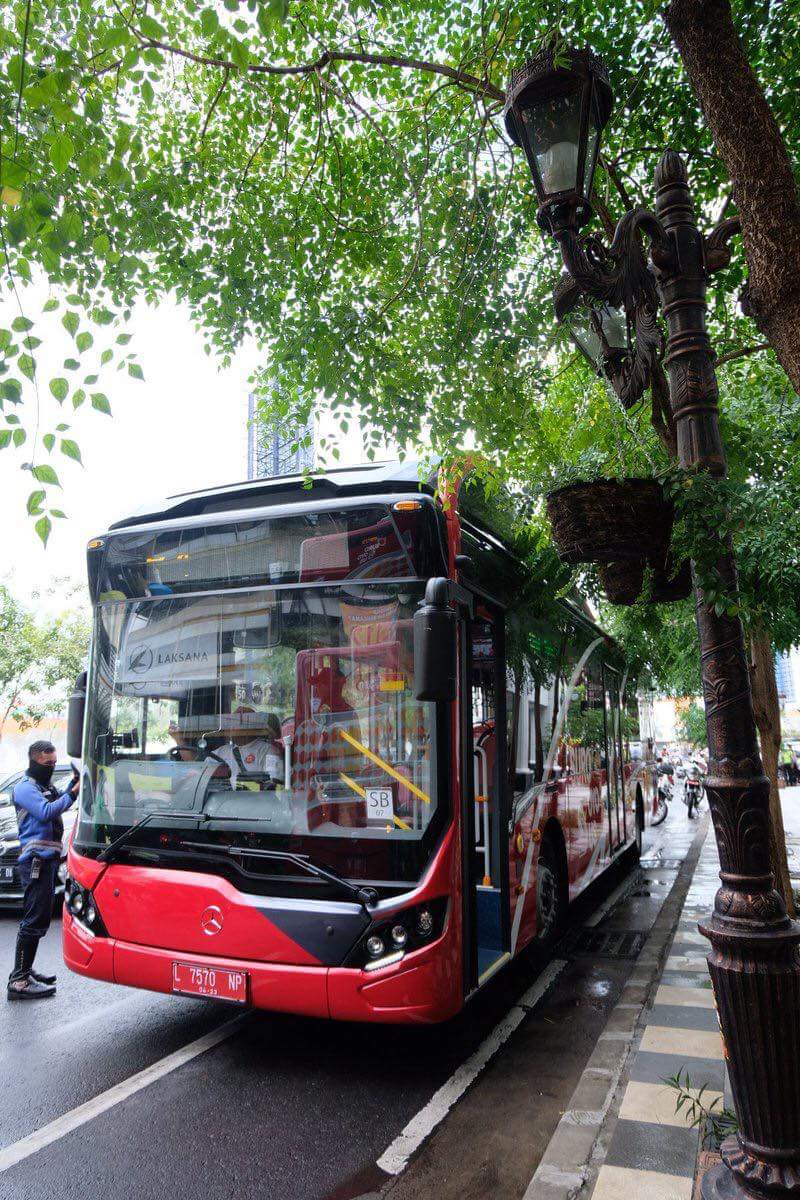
[64, 463, 655, 1022]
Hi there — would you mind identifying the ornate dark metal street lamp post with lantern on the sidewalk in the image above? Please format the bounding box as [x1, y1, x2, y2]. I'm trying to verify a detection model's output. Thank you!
[505, 50, 800, 1200]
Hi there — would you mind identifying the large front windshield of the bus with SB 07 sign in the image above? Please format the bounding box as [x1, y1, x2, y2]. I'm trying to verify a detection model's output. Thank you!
[76, 583, 444, 882]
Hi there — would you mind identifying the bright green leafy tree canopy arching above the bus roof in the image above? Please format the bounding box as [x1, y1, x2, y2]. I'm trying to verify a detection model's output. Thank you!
[0, 0, 800, 536]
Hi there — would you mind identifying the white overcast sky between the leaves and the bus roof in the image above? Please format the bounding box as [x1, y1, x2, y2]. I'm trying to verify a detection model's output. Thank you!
[0, 289, 388, 607]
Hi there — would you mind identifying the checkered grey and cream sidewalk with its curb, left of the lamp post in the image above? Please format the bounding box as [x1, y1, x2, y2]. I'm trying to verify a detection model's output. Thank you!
[524, 809, 724, 1200]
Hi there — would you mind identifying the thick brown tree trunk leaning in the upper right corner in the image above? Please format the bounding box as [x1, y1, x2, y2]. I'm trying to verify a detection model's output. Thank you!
[663, 0, 800, 392]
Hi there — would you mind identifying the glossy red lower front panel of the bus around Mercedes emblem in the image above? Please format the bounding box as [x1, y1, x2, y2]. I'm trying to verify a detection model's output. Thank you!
[62, 824, 463, 1024]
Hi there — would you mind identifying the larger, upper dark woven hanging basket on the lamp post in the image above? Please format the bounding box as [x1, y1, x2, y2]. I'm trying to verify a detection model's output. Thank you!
[547, 479, 673, 565]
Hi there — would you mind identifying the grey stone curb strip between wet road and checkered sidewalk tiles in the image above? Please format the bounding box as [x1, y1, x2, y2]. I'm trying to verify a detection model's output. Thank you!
[523, 811, 709, 1200]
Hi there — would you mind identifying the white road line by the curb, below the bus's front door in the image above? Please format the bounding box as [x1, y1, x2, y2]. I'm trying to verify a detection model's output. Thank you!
[378, 959, 566, 1175]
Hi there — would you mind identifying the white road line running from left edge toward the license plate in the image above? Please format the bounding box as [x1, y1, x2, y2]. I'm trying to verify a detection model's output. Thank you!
[0, 1013, 252, 1171]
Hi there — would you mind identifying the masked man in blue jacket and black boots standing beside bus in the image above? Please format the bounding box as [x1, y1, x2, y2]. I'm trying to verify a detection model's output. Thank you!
[7, 742, 79, 1000]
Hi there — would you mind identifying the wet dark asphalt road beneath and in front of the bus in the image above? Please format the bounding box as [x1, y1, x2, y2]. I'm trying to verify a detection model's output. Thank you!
[0, 804, 710, 1200]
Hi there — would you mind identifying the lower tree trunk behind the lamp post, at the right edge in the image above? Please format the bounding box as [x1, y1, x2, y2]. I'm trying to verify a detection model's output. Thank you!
[750, 625, 794, 917]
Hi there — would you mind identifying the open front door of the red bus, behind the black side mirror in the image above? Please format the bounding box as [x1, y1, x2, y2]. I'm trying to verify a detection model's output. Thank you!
[463, 604, 509, 990]
